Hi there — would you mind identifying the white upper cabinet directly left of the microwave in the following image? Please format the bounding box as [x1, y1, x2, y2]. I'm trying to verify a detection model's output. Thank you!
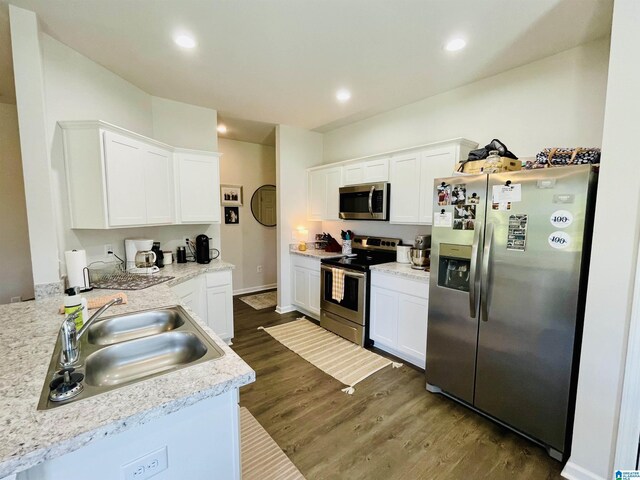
[307, 167, 342, 221]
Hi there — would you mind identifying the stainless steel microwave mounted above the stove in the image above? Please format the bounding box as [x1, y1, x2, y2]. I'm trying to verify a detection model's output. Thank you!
[340, 182, 389, 220]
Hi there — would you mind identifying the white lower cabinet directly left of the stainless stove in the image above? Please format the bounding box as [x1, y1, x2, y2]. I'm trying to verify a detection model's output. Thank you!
[291, 254, 320, 318]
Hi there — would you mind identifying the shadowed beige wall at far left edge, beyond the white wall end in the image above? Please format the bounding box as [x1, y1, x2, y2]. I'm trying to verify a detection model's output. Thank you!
[0, 103, 33, 304]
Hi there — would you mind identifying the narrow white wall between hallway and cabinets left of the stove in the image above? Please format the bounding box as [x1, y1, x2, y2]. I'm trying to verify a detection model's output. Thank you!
[276, 125, 322, 313]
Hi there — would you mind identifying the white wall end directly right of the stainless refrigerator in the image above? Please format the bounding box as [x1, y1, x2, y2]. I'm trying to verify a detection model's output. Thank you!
[563, 0, 640, 479]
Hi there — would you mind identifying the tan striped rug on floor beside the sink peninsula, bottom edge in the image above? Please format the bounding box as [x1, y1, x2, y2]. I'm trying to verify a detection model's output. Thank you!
[240, 407, 304, 480]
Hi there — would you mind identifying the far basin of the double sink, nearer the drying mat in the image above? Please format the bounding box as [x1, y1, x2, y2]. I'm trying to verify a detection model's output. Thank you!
[87, 308, 184, 345]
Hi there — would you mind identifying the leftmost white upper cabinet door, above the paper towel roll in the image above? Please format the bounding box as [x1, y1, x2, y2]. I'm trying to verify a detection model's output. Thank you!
[104, 132, 147, 227]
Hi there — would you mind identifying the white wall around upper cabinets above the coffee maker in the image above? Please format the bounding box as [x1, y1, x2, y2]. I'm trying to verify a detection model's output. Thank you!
[40, 33, 220, 273]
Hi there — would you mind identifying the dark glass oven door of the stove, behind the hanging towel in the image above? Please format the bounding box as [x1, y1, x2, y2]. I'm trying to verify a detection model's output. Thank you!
[320, 265, 367, 325]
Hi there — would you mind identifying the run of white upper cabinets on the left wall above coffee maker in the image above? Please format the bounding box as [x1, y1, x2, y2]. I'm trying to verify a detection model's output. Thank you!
[59, 121, 220, 229]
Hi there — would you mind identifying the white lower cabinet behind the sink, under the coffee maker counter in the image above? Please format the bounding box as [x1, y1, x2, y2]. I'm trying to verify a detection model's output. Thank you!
[172, 270, 233, 344]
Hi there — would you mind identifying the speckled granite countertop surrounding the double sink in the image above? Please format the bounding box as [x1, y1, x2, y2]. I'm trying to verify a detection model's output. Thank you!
[0, 261, 255, 478]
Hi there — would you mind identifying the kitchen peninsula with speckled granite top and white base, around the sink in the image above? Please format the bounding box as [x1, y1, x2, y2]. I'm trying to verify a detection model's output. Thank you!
[0, 261, 255, 480]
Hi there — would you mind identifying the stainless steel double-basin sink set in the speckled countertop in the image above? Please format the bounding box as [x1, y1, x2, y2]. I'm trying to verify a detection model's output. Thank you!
[38, 305, 224, 410]
